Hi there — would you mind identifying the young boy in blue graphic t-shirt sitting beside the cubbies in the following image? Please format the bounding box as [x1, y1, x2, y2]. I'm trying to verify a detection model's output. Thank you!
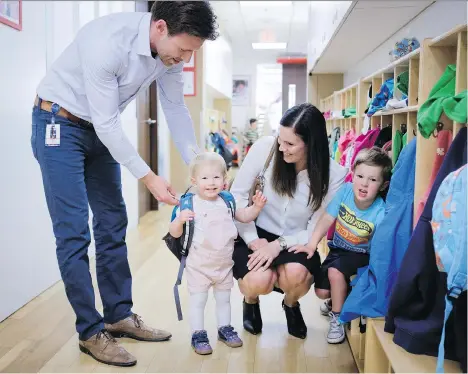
[290, 147, 392, 344]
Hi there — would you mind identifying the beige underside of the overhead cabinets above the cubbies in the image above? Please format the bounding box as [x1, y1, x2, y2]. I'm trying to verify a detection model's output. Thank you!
[313, 0, 434, 73]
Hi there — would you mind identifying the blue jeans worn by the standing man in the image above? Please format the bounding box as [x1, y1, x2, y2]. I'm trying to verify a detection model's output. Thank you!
[31, 103, 132, 340]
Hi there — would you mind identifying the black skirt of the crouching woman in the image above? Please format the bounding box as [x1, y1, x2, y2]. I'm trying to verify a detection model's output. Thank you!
[232, 226, 320, 279]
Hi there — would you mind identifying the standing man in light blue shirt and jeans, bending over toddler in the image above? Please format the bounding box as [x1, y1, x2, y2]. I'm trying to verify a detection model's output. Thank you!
[31, 1, 217, 366]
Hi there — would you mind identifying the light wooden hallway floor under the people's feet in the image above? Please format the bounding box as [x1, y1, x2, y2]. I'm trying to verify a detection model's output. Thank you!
[0, 207, 357, 373]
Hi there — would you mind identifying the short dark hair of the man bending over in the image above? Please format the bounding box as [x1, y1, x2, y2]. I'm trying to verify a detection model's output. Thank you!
[151, 0, 219, 40]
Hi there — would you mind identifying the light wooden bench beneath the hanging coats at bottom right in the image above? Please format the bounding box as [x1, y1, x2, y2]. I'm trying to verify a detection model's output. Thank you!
[364, 318, 461, 373]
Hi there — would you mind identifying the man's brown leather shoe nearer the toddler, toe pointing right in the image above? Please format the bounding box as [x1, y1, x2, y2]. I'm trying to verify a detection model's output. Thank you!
[104, 314, 172, 342]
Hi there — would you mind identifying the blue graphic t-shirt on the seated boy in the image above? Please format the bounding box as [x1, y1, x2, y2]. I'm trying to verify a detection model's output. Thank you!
[327, 183, 385, 253]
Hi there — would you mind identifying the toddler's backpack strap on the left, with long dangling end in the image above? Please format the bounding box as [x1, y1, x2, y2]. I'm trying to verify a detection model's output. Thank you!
[173, 193, 195, 321]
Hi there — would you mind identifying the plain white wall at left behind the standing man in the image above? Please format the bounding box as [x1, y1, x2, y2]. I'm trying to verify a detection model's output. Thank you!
[0, 1, 138, 321]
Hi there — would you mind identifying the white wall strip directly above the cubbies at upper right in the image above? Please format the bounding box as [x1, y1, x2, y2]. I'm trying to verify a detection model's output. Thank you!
[344, 0, 467, 87]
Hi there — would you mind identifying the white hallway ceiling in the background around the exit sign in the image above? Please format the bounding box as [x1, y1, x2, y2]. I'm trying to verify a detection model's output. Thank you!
[210, 1, 309, 63]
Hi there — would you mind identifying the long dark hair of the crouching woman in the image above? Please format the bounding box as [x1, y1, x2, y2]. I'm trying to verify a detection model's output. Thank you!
[273, 103, 330, 211]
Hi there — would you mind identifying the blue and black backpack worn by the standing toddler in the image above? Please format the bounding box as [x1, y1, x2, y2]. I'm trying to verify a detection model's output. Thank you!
[163, 190, 236, 321]
